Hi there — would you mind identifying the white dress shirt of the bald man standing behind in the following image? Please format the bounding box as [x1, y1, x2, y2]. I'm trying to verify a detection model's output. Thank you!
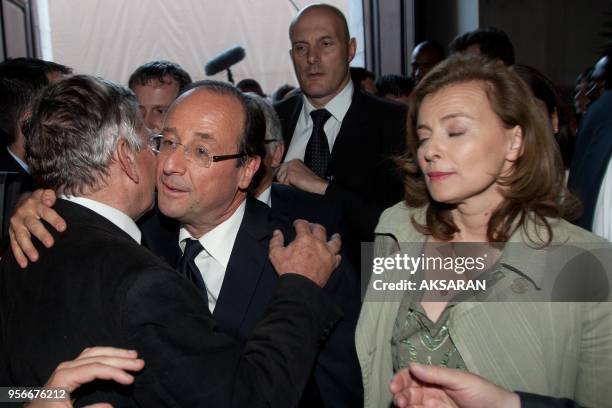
[285, 80, 354, 162]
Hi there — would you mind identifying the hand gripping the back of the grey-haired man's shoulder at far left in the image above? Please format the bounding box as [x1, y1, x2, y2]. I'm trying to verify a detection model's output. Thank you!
[9, 189, 66, 268]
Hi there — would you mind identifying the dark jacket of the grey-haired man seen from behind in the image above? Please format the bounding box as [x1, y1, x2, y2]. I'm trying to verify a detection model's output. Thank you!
[0, 200, 338, 407]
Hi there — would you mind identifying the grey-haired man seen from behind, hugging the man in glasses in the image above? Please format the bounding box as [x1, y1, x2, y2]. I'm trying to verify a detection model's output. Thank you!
[0, 76, 339, 407]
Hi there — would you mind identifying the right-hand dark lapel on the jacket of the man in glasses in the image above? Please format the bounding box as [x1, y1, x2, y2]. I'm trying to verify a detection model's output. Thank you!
[213, 197, 272, 335]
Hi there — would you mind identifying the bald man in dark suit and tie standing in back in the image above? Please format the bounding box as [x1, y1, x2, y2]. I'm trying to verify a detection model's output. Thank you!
[276, 4, 406, 259]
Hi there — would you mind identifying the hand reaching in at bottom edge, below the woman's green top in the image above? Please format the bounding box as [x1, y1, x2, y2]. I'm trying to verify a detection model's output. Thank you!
[389, 363, 521, 408]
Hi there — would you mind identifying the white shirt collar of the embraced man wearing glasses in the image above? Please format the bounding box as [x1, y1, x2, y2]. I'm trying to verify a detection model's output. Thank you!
[179, 200, 246, 269]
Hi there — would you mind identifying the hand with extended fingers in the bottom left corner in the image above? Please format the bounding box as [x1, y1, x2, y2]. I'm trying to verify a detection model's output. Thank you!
[27, 347, 144, 408]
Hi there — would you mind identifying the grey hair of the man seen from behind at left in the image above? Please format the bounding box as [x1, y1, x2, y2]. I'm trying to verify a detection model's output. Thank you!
[26, 75, 146, 196]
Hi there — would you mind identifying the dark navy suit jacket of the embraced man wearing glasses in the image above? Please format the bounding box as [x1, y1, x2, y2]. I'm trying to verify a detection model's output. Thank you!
[134, 196, 363, 407]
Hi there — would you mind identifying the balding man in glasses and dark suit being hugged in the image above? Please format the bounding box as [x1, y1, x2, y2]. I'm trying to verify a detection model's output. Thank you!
[157, 82, 361, 406]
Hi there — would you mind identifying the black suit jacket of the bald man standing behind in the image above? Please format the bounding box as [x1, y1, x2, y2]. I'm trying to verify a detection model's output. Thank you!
[275, 87, 406, 268]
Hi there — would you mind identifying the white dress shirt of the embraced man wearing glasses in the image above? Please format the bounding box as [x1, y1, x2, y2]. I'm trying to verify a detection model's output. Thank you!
[179, 201, 246, 313]
